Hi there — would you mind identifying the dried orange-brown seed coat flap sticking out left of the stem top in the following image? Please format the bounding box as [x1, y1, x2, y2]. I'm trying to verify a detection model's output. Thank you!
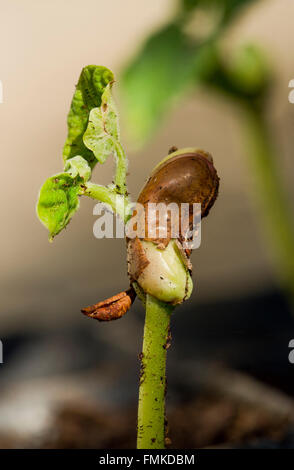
[81, 287, 136, 321]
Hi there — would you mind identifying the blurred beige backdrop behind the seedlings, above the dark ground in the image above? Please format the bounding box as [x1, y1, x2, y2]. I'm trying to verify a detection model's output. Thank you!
[0, 0, 294, 335]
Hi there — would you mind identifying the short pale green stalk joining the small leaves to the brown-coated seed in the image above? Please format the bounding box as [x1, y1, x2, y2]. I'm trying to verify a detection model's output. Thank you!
[81, 182, 130, 222]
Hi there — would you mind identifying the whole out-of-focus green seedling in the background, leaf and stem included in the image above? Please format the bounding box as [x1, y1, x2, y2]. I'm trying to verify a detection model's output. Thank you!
[122, 0, 294, 301]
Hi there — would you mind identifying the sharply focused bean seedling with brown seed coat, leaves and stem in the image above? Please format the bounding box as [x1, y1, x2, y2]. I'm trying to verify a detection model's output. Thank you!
[37, 65, 219, 449]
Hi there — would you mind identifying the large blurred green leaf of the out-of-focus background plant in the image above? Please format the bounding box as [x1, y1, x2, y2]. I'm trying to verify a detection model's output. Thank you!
[122, 24, 213, 144]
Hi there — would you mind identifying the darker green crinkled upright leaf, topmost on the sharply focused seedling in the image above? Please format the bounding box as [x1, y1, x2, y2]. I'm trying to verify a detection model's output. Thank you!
[63, 65, 114, 169]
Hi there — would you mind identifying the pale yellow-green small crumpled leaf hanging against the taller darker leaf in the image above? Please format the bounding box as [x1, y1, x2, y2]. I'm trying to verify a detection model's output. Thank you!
[84, 84, 119, 163]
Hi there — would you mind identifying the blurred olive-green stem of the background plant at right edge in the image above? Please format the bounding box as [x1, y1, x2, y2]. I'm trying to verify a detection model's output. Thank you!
[245, 106, 294, 301]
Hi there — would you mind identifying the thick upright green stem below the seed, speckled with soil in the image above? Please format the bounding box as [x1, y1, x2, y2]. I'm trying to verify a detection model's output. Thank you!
[137, 294, 173, 449]
